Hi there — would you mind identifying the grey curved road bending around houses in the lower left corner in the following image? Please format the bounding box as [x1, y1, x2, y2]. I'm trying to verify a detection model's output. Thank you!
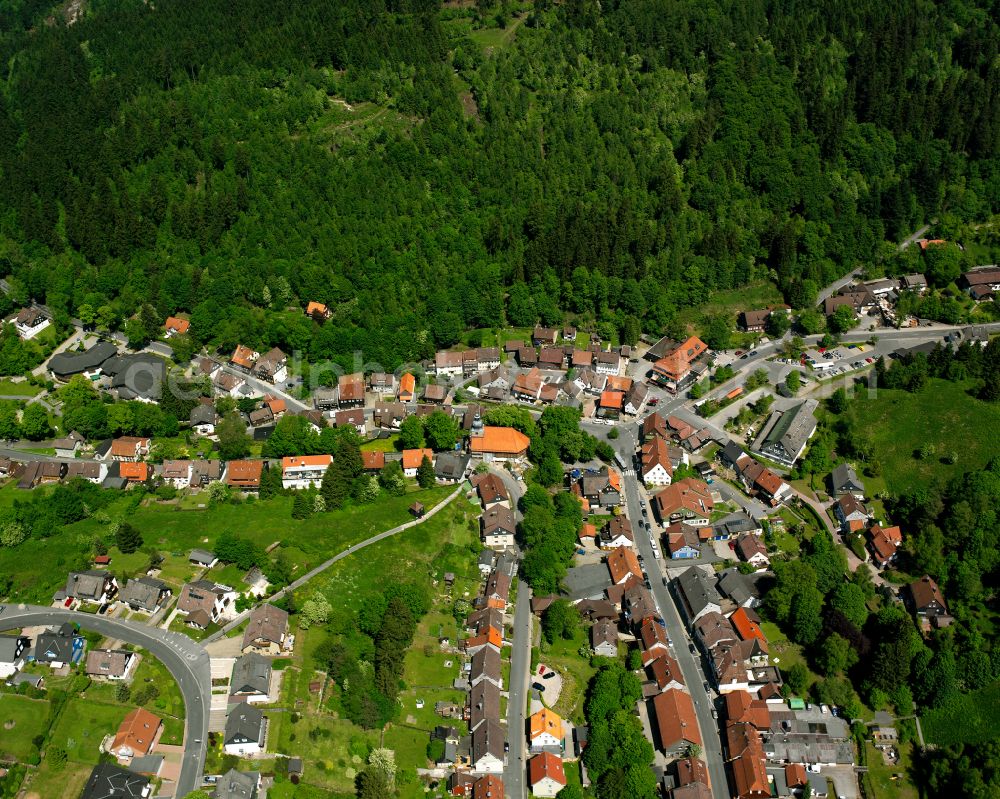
[0, 605, 212, 797]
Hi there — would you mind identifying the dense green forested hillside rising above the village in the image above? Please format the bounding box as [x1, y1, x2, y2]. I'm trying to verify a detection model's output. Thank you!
[0, 0, 1000, 366]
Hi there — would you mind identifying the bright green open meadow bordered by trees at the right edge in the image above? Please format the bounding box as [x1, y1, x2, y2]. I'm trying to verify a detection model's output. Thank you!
[847, 380, 1000, 494]
